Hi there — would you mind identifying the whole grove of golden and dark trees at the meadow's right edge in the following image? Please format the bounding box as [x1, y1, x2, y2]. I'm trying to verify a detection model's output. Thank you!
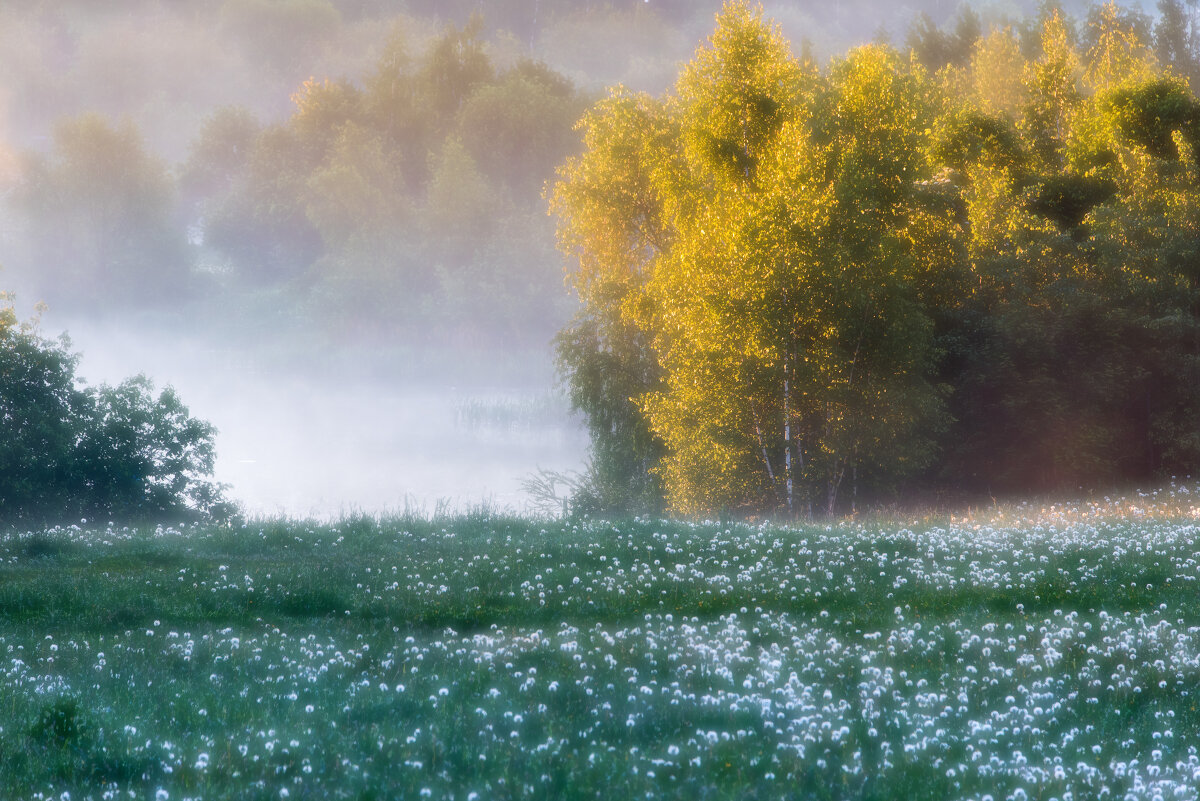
[552, 0, 1200, 516]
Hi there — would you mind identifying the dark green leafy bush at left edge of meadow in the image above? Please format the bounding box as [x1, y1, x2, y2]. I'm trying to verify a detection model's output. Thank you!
[0, 299, 232, 524]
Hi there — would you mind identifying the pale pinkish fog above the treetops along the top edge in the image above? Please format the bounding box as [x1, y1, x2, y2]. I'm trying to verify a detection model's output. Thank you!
[0, 0, 1132, 154]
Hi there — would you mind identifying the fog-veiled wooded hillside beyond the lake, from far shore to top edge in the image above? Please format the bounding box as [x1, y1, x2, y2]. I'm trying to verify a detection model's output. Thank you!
[0, 0, 945, 351]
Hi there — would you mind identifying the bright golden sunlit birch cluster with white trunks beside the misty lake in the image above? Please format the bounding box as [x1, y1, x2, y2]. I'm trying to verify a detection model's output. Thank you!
[556, 4, 949, 513]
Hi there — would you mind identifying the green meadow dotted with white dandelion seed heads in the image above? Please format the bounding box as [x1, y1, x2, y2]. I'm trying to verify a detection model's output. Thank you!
[7, 486, 1200, 801]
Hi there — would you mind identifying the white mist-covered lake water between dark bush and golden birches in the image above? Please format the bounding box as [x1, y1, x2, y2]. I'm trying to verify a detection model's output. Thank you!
[58, 315, 588, 518]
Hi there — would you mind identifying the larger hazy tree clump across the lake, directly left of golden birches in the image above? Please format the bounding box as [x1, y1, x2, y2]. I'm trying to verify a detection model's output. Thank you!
[177, 19, 582, 345]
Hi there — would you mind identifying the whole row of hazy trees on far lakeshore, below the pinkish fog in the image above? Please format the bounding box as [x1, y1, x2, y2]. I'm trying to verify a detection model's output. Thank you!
[8, 18, 586, 345]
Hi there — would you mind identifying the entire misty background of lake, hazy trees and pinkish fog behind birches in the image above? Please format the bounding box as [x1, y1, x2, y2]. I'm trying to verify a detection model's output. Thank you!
[0, 0, 1171, 516]
